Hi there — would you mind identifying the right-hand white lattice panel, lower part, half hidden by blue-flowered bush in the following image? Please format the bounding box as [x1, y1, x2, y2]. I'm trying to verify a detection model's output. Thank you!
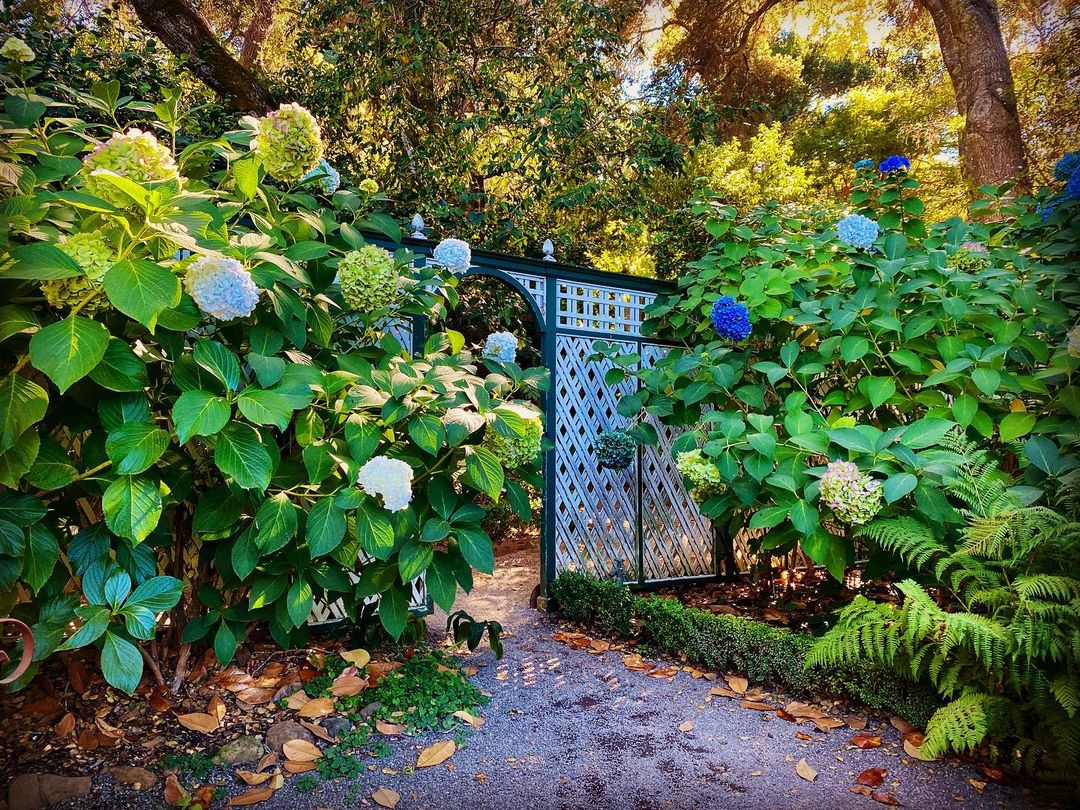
[642, 343, 716, 581]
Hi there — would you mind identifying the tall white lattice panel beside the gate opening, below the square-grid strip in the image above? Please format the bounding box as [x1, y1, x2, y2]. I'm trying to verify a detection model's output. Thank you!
[552, 335, 637, 579]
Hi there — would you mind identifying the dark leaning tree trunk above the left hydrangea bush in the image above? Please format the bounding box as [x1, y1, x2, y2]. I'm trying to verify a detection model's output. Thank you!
[129, 0, 276, 112]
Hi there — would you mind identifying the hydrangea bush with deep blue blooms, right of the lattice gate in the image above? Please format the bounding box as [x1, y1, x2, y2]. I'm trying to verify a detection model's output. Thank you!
[594, 158, 1080, 579]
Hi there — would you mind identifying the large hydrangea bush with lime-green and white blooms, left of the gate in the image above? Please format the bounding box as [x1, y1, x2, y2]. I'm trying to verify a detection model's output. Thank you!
[0, 72, 543, 692]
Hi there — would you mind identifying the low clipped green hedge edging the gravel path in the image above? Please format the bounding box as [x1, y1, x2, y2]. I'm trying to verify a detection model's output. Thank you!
[549, 571, 941, 727]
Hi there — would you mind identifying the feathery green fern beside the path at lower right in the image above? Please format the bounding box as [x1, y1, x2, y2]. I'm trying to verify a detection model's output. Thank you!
[807, 435, 1080, 782]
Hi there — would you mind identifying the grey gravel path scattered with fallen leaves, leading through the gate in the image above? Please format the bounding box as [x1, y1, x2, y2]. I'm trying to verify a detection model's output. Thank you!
[56, 552, 1034, 810]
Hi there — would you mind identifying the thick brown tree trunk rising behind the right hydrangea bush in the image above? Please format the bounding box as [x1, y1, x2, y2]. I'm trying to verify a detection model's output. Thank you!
[919, 0, 1029, 190]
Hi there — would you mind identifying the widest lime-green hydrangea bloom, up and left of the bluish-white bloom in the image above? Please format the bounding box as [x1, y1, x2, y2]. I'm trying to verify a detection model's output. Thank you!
[81, 129, 180, 208]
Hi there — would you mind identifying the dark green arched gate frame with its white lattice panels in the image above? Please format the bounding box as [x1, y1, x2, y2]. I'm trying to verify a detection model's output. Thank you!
[375, 239, 718, 593]
